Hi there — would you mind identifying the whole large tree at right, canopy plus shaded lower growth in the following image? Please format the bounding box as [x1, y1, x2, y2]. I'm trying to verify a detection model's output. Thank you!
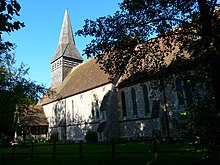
[77, 0, 220, 148]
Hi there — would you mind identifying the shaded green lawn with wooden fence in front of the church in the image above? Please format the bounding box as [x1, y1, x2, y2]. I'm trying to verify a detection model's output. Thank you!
[0, 142, 220, 165]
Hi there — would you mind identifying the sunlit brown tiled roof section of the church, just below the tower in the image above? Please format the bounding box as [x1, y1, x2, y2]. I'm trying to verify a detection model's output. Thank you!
[39, 58, 111, 105]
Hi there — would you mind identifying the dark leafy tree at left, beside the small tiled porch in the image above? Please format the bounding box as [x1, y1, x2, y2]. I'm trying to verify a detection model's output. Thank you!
[0, 54, 45, 140]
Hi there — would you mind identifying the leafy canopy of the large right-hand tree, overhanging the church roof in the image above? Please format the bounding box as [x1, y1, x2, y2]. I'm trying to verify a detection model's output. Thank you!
[77, 0, 219, 77]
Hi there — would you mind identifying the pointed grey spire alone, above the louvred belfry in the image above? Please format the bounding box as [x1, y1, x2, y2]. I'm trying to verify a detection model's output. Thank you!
[51, 9, 83, 63]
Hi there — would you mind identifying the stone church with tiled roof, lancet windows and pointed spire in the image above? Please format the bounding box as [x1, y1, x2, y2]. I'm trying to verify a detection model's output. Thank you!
[38, 10, 187, 141]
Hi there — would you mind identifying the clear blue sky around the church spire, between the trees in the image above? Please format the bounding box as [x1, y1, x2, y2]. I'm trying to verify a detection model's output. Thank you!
[5, 0, 122, 87]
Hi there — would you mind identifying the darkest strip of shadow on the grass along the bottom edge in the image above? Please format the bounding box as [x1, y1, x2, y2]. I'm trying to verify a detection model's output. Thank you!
[0, 153, 220, 165]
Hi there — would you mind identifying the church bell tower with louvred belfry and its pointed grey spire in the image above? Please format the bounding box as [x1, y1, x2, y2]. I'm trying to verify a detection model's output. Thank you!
[51, 9, 83, 88]
